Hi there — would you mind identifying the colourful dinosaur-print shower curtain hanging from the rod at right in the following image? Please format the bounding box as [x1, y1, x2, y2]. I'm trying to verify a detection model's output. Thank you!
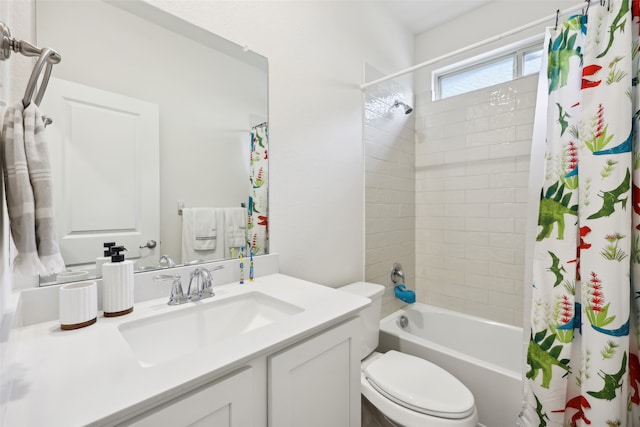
[519, 0, 640, 427]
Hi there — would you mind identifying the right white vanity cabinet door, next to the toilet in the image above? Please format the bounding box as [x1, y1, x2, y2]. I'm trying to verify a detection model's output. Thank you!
[268, 320, 360, 427]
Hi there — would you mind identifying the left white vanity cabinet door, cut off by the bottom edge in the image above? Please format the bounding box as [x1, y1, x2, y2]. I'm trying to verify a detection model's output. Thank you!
[125, 367, 253, 427]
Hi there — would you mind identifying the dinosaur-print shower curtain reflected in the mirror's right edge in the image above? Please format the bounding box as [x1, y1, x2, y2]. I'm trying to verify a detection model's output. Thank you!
[246, 123, 269, 255]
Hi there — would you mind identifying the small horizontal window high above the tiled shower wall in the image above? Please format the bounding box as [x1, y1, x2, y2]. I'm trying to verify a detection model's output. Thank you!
[432, 37, 543, 100]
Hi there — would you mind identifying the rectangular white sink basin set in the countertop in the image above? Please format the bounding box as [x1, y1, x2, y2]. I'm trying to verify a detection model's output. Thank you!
[118, 291, 303, 366]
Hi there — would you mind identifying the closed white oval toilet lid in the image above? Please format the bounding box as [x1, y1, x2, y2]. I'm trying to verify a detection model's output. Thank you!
[364, 350, 474, 419]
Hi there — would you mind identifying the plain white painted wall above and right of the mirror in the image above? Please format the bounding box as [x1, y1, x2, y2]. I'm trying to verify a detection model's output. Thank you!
[1, 1, 414, 300]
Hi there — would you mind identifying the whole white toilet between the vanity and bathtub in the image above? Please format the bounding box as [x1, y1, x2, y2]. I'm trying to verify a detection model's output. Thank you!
[339, 282, 478, 427]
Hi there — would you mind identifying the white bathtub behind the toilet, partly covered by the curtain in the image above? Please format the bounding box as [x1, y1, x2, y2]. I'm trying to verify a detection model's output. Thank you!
[378, 303, 522, 427]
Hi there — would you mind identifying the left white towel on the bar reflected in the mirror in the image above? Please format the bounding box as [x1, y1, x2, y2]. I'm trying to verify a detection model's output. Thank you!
[182, 208, 224, 264]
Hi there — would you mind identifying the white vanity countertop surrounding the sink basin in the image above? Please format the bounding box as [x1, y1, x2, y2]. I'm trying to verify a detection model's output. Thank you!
[0, 274, 369, 427]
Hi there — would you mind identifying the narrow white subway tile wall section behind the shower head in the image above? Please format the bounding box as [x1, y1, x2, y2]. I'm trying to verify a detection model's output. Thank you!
[364, 82, 416, 316]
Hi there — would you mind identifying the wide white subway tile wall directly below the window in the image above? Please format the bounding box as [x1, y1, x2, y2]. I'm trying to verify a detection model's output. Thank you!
[415, 76, 537, 326]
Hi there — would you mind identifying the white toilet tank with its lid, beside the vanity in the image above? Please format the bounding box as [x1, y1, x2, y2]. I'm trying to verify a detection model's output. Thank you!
[338, 282, 384, 360]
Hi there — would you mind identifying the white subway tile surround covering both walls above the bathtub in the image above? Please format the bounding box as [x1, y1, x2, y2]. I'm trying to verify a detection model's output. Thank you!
[365, 76, 537, 326]
